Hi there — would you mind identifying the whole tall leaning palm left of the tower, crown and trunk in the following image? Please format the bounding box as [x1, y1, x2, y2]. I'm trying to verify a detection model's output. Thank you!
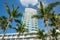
[2, 3, 22, 39]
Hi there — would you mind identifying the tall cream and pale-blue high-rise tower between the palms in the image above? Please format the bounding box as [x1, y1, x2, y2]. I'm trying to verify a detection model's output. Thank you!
[23, 8, 38, 33]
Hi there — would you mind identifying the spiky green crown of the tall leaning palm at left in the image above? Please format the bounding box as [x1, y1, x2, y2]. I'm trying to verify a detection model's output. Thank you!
[5, 3, 22, 22]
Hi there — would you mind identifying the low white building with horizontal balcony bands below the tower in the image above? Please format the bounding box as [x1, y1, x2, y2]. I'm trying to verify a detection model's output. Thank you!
[0, 33, 38, 40]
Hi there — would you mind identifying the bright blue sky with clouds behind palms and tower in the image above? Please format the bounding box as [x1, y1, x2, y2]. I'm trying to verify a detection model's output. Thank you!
[0, 0, 60, 33]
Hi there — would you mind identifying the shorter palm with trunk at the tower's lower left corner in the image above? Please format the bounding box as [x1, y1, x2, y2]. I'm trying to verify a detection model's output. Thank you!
[12, 19, 28, 40]
